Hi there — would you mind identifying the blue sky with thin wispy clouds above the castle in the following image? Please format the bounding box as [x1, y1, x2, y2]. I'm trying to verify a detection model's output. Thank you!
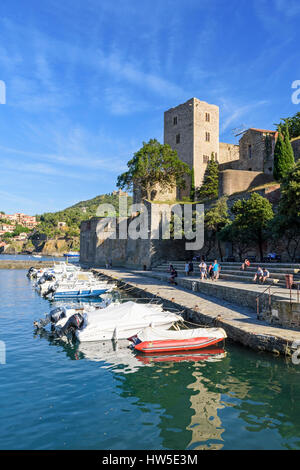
[0, 0, 300, 214]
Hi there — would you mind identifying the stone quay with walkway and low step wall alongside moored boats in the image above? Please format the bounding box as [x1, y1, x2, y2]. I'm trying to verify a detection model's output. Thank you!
[93, 268, 300, 356]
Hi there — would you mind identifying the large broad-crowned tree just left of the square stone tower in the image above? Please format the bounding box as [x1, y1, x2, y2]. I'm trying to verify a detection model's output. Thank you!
[117, 139, 191, 200]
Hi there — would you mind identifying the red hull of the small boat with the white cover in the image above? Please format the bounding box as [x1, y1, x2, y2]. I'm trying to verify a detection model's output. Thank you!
[134, 337, 224, 354]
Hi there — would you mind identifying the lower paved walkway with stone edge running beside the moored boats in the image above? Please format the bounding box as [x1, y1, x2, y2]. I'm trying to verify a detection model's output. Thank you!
[94, 268, 300, 354]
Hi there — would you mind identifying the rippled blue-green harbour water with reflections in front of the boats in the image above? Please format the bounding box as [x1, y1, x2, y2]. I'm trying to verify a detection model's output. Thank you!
[0, 270, 300, 450]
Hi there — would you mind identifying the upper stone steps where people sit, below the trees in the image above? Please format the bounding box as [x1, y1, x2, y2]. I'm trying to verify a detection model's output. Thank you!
[152, 261, 300, 287]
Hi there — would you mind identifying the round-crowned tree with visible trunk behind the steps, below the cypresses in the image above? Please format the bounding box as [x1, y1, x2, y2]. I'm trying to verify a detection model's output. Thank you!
[231, 193, 274, 261]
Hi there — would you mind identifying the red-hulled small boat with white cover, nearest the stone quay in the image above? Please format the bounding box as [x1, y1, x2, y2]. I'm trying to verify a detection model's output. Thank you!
[129, 326, 227, 354]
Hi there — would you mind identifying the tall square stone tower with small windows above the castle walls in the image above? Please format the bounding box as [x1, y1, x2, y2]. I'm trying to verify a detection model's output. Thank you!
[164, 98, 219, 198]
